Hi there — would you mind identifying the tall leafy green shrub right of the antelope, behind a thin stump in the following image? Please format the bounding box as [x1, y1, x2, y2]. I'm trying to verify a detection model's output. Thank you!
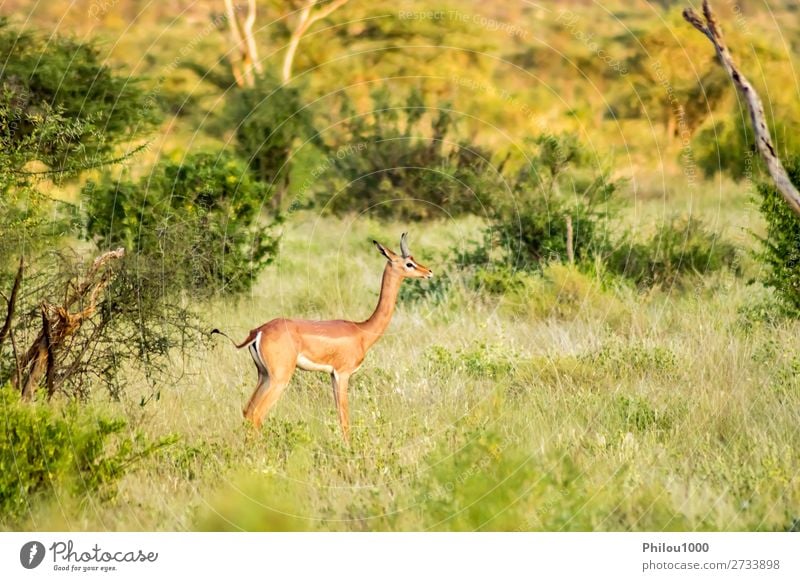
[455, 134, 618, 282]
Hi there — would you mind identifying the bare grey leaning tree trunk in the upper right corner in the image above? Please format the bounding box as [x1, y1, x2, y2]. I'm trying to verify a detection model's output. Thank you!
[683, 0, 800, 217]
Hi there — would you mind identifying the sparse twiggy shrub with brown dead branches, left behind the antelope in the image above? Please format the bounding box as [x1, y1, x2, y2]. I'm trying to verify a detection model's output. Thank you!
[0, 244, 199, 398]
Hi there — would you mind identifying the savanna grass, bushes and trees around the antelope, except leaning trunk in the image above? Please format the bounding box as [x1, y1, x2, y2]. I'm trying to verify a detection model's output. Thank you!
[0, 0, 800, 531]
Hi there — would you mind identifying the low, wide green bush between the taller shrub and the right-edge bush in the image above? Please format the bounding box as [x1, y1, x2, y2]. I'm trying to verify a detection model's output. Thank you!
[605, 216, 739, 287]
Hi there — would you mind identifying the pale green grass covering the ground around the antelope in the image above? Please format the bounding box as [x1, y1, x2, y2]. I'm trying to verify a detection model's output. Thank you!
[7, 208, 800, 531]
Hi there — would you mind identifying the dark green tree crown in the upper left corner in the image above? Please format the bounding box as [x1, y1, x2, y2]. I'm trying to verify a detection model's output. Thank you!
[0, 20, 157, 177]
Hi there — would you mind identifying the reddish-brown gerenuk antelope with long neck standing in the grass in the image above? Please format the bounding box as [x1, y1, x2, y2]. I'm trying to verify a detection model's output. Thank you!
[211, 234, 433, 440]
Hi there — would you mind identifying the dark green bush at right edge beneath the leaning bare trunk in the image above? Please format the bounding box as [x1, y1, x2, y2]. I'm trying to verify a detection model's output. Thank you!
[758, 157, 800, 317]
